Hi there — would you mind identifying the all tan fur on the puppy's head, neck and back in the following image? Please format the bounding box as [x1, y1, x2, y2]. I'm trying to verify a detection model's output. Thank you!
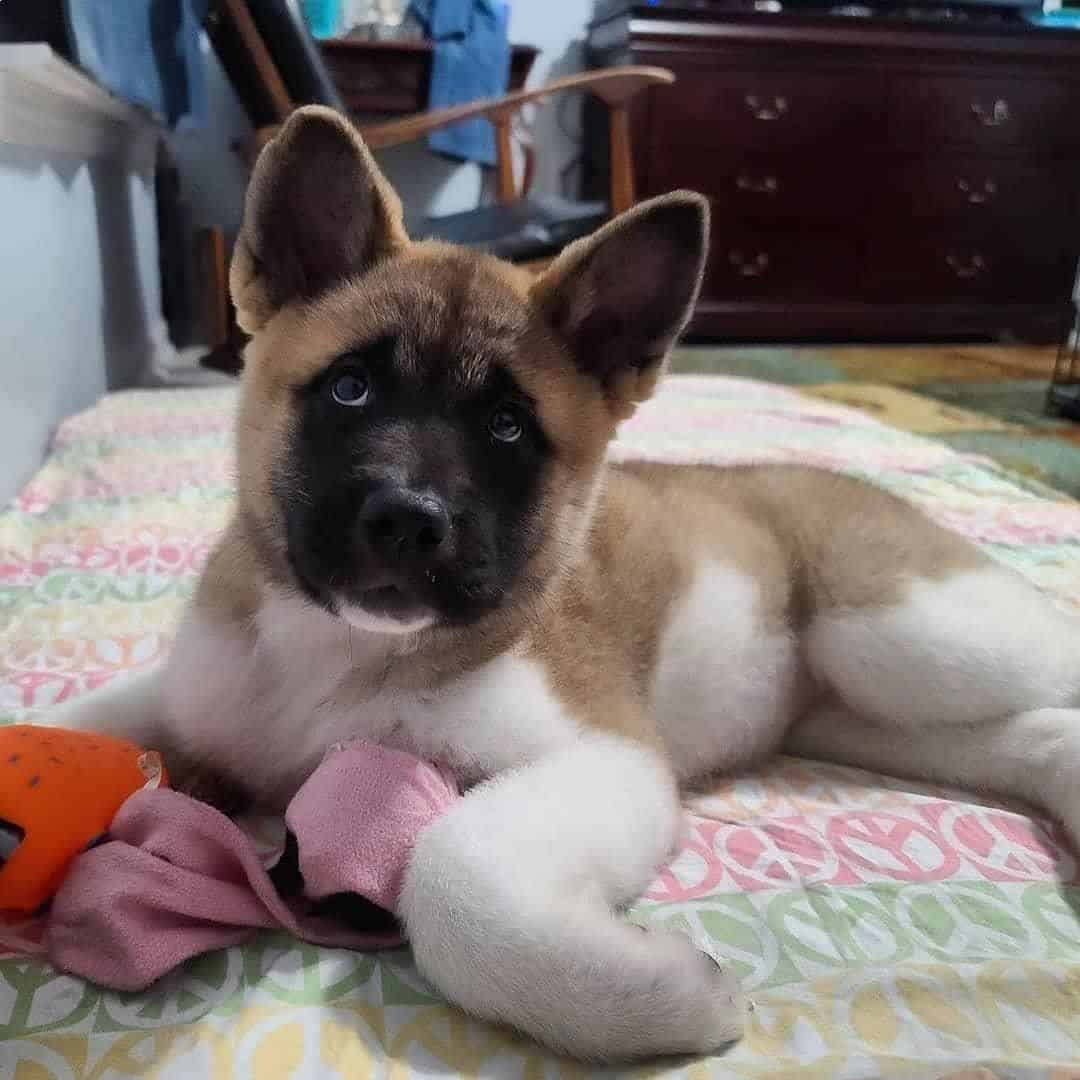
[208, 105, 982, 764]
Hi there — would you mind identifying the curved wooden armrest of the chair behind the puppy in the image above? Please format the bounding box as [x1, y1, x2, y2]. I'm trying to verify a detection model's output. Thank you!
[360, 66, 675, 150]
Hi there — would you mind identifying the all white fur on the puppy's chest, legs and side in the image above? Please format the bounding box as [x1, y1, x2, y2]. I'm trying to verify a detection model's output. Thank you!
[44, 564, 1080, 1059]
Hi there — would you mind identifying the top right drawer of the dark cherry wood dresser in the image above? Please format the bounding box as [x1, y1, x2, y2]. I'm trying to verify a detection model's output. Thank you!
[889, 76, 1080, 152]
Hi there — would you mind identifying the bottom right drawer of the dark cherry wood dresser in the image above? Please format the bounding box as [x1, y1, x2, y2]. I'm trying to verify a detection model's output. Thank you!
[865, 221, 1077, 303]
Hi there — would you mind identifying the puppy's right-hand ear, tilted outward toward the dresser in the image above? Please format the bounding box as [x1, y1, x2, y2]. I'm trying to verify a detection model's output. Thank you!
[531, 191, 708, 416]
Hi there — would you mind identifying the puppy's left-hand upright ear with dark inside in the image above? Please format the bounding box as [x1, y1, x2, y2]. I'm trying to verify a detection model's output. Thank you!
[229, 106, 408, 334]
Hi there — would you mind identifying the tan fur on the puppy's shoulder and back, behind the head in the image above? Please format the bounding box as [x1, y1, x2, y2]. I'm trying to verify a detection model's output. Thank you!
[522, 464, 989, 743]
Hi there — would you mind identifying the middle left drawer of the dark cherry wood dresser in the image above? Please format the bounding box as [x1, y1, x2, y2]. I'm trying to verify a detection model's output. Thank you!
[649, 147, 873, 221]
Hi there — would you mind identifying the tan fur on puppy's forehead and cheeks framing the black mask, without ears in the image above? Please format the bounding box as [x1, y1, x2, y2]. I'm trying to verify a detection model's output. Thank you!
[231, 243, 615, 685]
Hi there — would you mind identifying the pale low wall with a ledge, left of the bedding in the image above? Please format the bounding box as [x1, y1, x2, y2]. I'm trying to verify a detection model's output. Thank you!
[0, 46, 167, 504]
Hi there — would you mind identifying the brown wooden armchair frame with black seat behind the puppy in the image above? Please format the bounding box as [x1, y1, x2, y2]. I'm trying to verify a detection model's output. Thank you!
[204, 0, 675, 370]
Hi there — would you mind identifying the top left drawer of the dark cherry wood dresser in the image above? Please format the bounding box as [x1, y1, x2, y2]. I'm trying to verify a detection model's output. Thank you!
[649, 68, 886, 160]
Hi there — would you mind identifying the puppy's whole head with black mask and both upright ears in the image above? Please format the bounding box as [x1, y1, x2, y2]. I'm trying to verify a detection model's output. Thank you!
[230, 108, 706, 632]
